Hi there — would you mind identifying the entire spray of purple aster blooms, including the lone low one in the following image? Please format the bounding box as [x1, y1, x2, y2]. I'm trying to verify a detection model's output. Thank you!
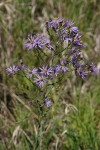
[7, 18, 97, 107]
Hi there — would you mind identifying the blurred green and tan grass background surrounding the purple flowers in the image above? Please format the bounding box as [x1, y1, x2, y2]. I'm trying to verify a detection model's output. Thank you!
[0, 0, 100, 150]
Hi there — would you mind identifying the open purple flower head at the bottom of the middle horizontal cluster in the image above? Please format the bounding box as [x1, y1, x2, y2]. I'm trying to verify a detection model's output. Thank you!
[34, 75, 47, 88]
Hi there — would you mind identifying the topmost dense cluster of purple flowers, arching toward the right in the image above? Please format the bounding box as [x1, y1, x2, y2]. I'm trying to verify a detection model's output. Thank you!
[46, 18, 84, 47]
